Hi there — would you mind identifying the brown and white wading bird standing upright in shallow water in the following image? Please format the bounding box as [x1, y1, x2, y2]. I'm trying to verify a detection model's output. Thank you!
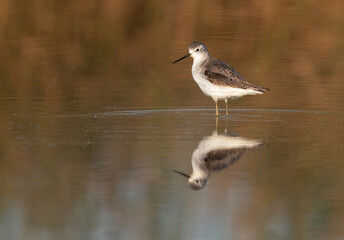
[173, 41, 269, 117]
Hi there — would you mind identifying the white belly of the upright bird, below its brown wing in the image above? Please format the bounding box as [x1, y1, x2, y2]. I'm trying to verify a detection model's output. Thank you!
[192, 71, 262, 101]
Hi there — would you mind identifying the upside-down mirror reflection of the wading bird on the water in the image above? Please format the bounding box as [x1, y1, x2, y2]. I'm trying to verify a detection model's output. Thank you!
[173, 130, 264, 190]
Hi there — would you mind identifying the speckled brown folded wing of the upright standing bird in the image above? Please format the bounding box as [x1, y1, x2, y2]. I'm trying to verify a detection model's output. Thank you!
[204, 58, 269, 92]
